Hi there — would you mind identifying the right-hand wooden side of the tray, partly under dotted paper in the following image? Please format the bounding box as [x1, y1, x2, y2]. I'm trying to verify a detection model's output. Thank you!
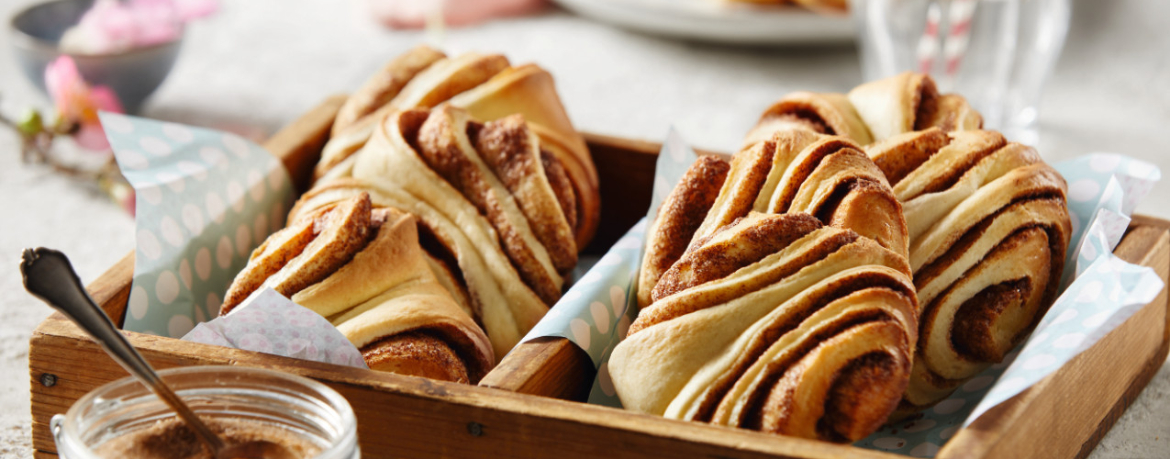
[938, 227, 1170, 459]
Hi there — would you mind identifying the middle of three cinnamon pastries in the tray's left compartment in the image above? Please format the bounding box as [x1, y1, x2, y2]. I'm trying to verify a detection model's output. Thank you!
[289, 105, 577, 356]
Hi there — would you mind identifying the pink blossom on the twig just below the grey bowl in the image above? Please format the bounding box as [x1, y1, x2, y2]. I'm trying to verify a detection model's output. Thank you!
[44, 56, 123, 151]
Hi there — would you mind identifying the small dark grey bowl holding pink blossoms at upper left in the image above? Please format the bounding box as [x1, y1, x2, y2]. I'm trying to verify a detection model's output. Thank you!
[11, 0, 183, 112]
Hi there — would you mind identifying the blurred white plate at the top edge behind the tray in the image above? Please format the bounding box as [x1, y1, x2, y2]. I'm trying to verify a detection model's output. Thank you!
[556, 0, 853, 44]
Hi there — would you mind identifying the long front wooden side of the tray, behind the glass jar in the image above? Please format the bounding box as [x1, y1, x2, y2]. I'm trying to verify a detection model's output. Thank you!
[29, 316, 897, 459]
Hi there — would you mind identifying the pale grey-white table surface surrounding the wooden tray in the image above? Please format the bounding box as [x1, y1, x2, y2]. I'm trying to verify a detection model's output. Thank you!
[0, 0, 1170, 459]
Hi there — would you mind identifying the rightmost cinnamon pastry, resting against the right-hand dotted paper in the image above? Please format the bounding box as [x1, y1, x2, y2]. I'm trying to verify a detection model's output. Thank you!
[868, 128, 1072, 415]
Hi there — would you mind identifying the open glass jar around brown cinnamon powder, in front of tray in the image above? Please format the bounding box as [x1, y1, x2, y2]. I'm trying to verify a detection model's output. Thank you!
[50, 366, 362, 459]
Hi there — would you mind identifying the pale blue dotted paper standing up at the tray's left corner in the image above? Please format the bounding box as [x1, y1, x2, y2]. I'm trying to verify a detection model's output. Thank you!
[101, 112, 295, 337]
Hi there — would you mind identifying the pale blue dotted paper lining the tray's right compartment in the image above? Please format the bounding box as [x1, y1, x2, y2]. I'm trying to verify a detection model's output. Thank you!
[525, 130, 1162, 458]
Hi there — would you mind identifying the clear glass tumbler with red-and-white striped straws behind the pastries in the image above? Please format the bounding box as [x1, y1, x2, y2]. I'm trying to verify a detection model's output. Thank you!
[849, 0, 1069, 145]
